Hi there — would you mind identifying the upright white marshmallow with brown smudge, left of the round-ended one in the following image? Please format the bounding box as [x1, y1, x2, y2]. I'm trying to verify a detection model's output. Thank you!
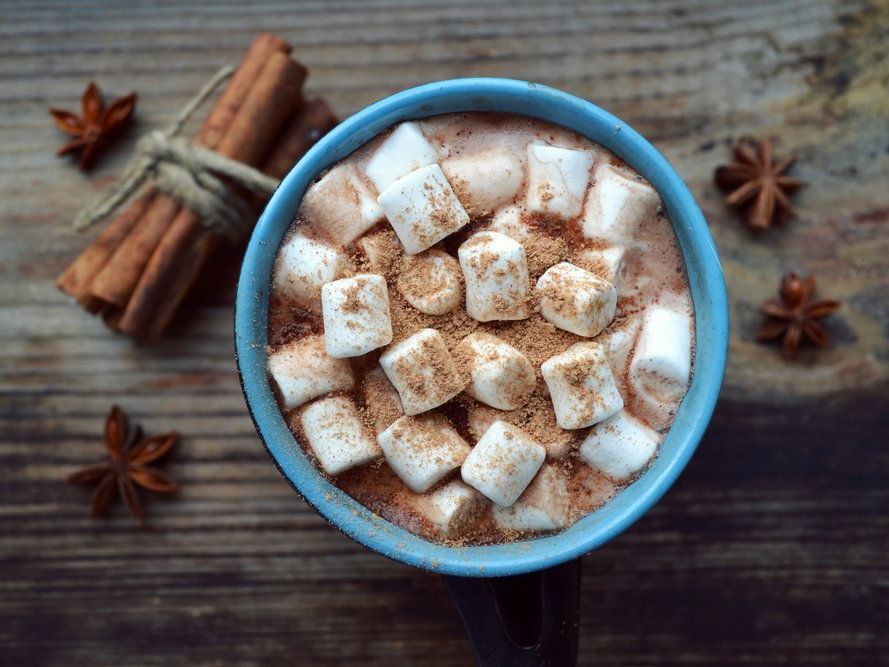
[321, 273, 392, 359]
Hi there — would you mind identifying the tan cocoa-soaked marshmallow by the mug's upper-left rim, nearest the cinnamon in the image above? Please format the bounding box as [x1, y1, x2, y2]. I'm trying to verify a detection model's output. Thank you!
[300, 163, 384, 246]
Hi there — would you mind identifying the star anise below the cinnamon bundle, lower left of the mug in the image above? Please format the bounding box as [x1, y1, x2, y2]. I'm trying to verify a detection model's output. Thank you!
[68, 405, 179, 525]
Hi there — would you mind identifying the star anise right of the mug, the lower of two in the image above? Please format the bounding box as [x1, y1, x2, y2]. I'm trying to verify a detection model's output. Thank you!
[756, 273, 840, 359]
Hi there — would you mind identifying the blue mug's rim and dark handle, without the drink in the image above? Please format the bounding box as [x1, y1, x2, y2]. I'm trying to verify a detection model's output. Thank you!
[235, 78, 728, 665]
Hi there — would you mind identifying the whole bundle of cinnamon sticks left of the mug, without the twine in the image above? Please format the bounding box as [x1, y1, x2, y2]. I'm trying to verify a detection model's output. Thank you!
[56, 33, 337, 340]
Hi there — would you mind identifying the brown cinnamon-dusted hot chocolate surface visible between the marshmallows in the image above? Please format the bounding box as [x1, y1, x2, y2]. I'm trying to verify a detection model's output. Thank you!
[269, 112, 694, 545]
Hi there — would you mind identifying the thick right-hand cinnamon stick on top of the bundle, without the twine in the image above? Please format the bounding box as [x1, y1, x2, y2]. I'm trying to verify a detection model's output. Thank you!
[118, 53, 306, 340]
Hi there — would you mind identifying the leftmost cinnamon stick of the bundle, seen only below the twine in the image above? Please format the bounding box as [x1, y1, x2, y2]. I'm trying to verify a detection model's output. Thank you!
[56, 188, 154, 313]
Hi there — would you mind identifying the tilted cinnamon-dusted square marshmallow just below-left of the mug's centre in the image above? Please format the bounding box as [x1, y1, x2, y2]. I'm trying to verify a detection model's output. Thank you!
[380, 329, 466, 415]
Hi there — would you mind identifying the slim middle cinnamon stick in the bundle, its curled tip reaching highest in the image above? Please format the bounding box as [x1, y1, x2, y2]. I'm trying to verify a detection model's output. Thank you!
[70, 33, 290, 308]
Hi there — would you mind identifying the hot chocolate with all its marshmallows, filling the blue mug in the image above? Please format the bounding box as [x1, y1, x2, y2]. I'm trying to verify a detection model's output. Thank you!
[269, 113, 694, 544]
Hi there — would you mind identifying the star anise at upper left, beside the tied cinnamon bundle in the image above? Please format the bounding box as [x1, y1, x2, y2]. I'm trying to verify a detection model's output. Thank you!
[49, 81, 136, 170]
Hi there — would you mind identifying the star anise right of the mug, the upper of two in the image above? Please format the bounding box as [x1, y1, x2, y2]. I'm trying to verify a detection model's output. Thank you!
[714, 139, 806, 229]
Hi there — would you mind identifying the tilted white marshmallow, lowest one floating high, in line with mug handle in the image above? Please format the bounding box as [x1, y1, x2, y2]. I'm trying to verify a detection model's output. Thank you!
[460, 421, 546, 507]
